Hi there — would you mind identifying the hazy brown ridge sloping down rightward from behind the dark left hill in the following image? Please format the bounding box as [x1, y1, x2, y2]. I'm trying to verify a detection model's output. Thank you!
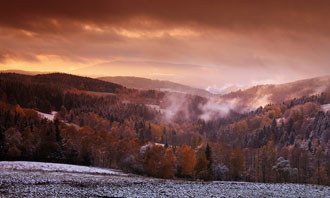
[98, 76, 212, 97]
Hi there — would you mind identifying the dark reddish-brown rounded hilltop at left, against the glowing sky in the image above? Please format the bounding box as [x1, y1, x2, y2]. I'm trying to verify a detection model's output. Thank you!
[0, 73, 125, 93]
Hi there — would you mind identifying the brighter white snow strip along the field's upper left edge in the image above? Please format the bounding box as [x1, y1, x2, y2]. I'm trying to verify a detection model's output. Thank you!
[0, 161, 125, 175]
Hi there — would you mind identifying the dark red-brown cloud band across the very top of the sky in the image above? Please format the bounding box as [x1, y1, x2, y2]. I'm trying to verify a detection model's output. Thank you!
[0, 0, 330, 34]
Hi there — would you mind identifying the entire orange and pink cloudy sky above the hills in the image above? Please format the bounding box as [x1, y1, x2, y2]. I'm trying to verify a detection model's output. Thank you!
[0, 0, 330, 90]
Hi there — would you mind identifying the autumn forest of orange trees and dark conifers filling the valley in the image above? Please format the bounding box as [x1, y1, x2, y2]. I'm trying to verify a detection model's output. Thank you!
[0, 73, 330, 185]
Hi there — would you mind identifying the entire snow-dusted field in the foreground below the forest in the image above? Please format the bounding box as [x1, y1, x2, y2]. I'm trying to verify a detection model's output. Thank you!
[0, 162, 330, 197]
